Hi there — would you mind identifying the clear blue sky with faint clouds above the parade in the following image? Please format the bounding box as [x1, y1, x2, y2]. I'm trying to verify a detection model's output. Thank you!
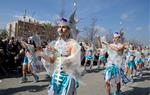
[0, 0, 150, 45]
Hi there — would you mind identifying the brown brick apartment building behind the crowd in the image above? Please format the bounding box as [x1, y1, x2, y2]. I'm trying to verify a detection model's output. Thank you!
[7, 20, 57, 41]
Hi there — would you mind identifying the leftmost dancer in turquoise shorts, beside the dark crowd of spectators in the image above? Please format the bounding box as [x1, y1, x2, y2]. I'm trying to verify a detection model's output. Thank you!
[20, 37, 39, 83]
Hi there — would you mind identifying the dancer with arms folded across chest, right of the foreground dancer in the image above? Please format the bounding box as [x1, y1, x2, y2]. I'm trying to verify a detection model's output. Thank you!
[105, 32, 129, 95]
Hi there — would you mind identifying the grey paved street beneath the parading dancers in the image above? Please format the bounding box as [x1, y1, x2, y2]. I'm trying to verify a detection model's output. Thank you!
[0, 69, 150, 95]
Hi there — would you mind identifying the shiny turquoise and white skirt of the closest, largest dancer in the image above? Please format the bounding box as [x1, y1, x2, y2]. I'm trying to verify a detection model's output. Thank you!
[48, 71, 79, 95]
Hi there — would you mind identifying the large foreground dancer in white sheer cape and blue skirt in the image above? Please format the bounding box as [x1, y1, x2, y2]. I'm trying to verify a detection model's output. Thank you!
[39, 18, 81, 95]
